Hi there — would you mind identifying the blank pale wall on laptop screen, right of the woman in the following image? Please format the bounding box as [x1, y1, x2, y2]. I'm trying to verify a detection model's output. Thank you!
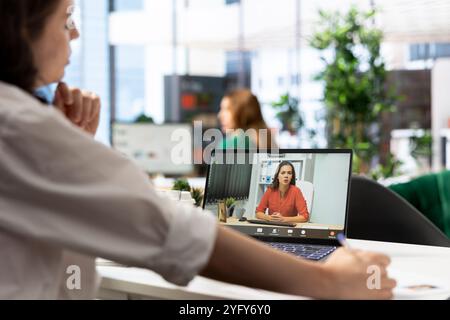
[311, 154, 350, 225]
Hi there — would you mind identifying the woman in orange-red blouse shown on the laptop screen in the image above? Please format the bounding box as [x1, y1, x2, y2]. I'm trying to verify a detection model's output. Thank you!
[256, 161, 309, 223]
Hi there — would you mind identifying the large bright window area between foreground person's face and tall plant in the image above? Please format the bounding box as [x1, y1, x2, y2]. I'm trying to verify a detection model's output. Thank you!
[111, 0, 323, 147]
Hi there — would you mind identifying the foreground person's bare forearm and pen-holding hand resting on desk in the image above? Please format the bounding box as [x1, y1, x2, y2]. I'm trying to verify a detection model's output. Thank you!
[202, 227, 395, 299]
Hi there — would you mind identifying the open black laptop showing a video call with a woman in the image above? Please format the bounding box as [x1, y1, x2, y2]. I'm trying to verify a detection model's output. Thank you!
[203, 149, 353, 261]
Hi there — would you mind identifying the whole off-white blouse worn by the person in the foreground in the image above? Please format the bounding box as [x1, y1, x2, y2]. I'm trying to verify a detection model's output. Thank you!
[0, 82, 217, 299]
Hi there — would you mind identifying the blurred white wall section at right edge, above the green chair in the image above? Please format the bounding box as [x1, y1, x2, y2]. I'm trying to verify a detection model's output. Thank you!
[431, 59, 450, 170]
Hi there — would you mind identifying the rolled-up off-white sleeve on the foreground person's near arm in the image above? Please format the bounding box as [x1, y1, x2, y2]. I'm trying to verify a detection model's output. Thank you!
[0, 106, 217, 285]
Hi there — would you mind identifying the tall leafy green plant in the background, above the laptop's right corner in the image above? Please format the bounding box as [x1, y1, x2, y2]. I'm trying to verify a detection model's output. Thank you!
[310, 7, 398, 178]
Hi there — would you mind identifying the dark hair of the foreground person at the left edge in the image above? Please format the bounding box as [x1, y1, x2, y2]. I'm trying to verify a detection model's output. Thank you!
[0, 0, 61, 93]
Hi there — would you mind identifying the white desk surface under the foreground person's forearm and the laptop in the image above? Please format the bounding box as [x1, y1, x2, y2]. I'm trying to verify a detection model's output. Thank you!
[98, 240, 450, 300]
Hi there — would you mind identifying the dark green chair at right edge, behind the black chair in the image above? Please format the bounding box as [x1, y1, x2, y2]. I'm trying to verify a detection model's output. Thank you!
[389, 171, 450, 238]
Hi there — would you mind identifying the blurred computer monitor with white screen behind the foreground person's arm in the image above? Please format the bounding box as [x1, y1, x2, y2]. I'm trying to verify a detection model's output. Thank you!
[113, 123, 194, 176]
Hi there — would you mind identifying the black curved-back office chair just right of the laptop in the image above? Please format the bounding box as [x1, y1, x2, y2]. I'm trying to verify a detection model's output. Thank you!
[348, 176, 450, 247]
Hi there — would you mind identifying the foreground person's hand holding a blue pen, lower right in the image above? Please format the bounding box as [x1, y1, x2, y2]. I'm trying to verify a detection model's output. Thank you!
[323, 248, 397, 299]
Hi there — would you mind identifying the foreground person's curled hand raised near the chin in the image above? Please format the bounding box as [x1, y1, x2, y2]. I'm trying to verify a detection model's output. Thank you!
[53, 82, 101, 136]
